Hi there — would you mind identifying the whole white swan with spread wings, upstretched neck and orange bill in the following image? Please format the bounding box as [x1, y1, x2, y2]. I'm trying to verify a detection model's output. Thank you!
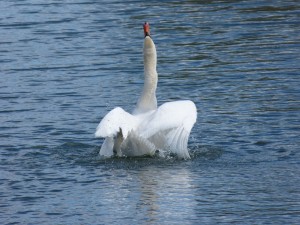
[95, 22, 197, 159]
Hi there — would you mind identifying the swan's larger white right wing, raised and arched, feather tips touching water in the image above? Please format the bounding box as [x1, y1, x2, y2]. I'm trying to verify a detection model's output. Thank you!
[138, 101, 197, 159]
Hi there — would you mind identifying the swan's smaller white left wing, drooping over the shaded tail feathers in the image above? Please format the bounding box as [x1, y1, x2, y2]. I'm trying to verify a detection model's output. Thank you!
[95, 107, 136, 138]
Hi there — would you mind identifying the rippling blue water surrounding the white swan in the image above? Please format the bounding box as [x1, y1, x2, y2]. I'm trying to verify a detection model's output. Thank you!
[0, 0, 300, 224]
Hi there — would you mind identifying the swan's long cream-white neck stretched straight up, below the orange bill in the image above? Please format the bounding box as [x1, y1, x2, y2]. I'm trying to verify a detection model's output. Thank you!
[135, 37, 157, 113]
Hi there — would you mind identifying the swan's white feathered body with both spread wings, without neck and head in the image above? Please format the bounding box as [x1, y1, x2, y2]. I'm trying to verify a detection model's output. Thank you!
[96, 101, 197, 159]
